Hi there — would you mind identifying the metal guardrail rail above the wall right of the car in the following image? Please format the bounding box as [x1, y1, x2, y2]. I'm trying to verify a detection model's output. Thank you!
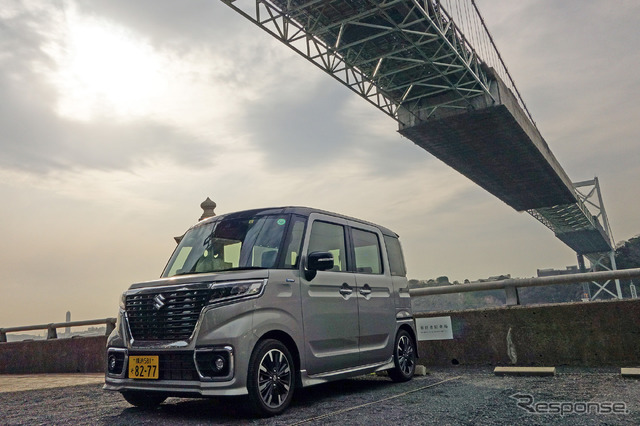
[409, 268, 640, 306]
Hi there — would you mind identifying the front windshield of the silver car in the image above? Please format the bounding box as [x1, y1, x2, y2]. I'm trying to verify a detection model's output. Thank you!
[162, 215, 288, 277]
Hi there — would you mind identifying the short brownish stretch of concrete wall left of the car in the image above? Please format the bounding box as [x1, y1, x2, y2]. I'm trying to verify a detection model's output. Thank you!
[0, 336, 107, 374]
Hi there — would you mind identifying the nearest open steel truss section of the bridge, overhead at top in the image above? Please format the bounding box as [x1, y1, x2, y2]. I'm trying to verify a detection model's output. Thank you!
[222, 0, 508, 125]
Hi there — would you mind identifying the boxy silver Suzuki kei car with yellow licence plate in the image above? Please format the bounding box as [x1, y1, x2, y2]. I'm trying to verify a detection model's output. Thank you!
[104, 207, 417, 416]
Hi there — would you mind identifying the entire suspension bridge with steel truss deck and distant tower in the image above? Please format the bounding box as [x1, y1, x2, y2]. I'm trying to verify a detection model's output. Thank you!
[222, 0, 621, 298]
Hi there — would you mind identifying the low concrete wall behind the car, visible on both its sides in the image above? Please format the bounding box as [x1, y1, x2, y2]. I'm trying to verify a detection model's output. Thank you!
[0, 299, 640, 374]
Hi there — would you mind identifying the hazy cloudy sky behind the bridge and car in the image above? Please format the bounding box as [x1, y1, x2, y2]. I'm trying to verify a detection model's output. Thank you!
[0, 0, 640, 327]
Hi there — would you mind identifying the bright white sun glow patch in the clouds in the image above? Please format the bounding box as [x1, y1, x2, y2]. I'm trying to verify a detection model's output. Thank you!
[50, 13, 167, 120]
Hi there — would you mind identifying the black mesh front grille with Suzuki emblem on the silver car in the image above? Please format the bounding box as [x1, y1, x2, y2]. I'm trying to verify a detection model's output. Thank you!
[126, 289, 211, 341]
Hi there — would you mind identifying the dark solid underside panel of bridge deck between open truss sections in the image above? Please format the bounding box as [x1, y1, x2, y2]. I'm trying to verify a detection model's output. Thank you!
[400, 105, 576, 211]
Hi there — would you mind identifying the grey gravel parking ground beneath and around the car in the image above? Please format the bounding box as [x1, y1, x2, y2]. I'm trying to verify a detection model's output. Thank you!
[0, 367, 640, 426]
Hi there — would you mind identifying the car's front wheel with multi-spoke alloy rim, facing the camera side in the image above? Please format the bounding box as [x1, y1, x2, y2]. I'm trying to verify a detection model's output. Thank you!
[247, 339, 296, 417]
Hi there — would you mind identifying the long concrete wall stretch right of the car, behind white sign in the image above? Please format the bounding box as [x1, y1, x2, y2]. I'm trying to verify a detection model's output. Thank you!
[416, 299, 640, 367]
